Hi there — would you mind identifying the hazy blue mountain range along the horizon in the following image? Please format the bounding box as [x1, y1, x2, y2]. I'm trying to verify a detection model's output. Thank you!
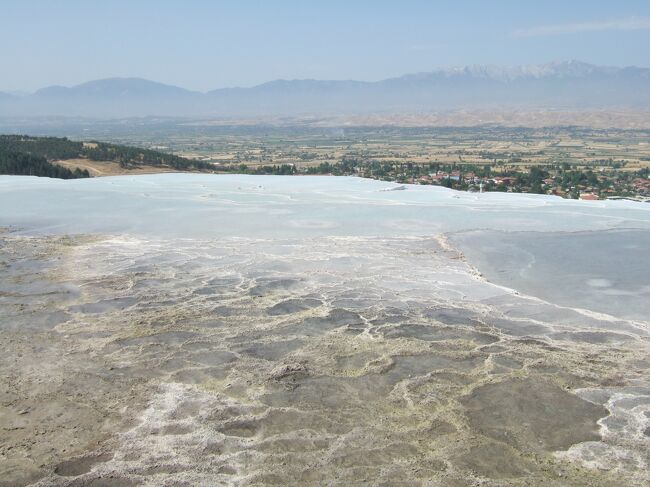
[0, 61, 650, 118]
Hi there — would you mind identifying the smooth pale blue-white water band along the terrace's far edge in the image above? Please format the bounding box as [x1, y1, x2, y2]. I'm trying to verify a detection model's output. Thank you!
[0, 174, 650, 238]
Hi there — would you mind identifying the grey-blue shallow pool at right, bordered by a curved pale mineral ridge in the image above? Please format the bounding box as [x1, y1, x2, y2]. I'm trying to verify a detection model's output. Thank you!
[452, 230, 650, 321]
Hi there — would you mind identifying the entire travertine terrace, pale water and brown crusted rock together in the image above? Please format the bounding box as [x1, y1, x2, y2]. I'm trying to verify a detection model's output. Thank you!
[0, 175, 650, 486]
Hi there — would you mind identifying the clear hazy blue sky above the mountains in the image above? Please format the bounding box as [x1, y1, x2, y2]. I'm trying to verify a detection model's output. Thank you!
[0, 0, 650, 91]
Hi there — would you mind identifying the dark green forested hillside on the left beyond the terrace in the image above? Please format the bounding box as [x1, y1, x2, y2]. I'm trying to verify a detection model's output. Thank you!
[0, 135, 211, 179]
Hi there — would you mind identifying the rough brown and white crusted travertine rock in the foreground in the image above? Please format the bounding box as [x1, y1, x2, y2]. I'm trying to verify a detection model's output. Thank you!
[0, 234, 650, 486]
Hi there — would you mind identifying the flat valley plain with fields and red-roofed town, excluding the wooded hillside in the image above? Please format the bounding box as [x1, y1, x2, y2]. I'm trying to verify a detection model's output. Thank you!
[73, 125, 650, 201]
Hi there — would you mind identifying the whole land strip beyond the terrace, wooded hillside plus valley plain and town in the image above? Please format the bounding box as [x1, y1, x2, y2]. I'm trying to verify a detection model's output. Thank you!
[0, 129, 650, 202]
